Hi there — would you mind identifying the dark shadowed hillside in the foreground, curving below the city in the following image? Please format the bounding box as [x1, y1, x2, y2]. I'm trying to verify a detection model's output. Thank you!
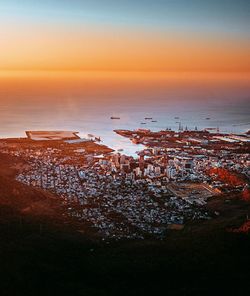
[0, 154, 250, 296]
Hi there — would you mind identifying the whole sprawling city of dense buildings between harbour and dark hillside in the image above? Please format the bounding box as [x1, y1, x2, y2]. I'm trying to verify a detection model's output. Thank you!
[3, 130, 250, 239]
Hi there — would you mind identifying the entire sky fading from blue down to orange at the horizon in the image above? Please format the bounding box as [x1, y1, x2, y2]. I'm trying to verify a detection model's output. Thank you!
[0, 0, 250, 72]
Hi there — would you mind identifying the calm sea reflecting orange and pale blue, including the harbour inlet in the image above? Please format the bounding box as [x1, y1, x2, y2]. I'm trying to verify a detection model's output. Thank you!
[0, 74, 250, 155]
